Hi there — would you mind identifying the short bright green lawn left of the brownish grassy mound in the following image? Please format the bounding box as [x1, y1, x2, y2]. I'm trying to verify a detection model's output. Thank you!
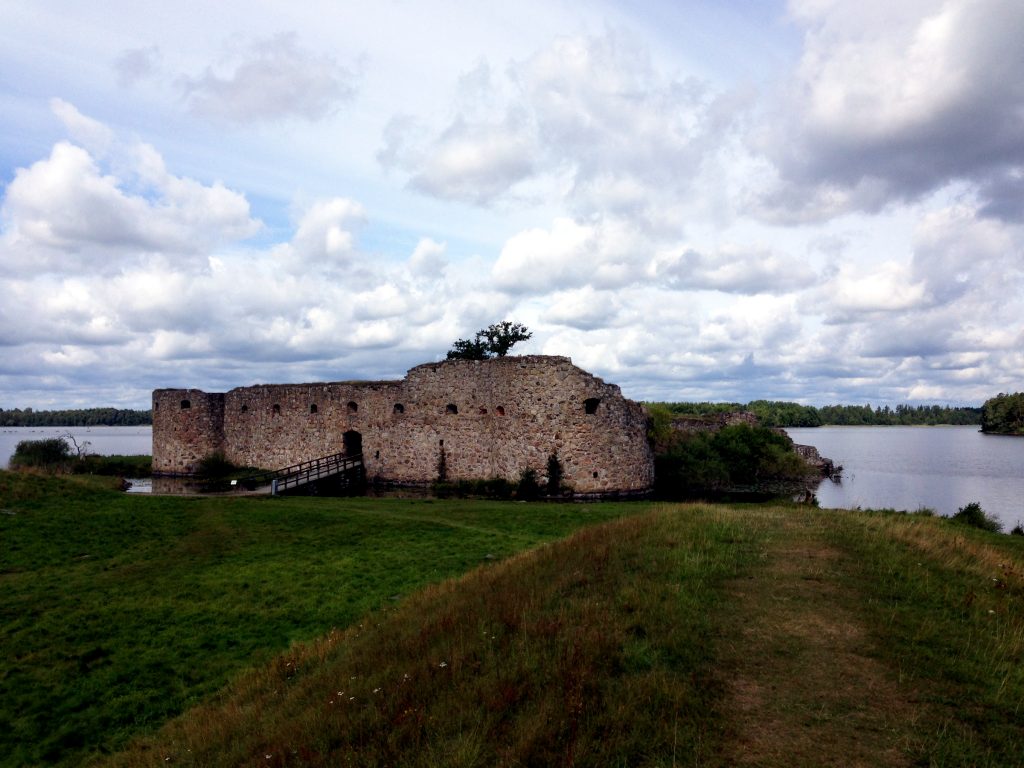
[0, 472, 642, 766]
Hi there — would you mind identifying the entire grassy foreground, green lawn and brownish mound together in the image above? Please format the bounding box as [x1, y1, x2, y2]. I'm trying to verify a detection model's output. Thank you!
[0, 474, 1024, 766]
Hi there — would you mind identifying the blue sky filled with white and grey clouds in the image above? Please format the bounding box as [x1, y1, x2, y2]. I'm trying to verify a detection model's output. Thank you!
[0, 0, 1024, 409]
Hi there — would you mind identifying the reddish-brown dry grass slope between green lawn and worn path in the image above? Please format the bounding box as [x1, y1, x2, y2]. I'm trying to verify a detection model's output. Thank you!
[99, 507, 757, 766]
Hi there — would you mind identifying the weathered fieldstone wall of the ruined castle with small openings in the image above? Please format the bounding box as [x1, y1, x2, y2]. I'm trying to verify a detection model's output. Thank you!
[153, 355, 654, 495]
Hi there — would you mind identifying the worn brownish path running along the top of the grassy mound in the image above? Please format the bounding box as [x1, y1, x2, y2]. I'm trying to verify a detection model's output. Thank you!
[720, 517, 918, 766]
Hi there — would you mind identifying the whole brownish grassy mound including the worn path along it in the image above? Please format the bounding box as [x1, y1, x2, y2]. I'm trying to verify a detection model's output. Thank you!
[99, 505, 1024, 767]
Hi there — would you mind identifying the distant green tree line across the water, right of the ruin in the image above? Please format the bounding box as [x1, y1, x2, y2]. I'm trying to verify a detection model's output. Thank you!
[648, 400, 982, 427]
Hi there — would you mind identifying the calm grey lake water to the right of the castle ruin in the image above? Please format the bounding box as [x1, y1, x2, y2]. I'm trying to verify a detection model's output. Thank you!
[786, 427, 1024, 530]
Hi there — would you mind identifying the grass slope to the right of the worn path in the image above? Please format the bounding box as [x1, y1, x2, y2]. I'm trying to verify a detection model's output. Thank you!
[833, 513, 1024, 766]
